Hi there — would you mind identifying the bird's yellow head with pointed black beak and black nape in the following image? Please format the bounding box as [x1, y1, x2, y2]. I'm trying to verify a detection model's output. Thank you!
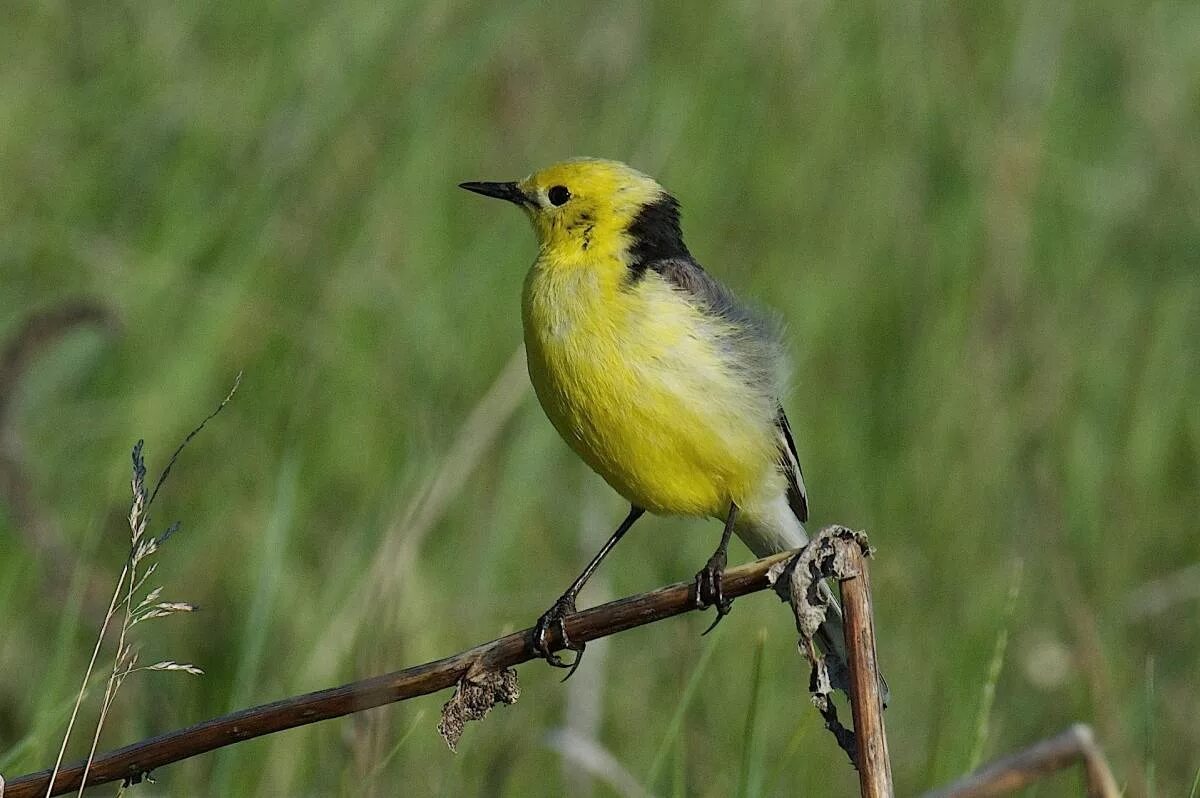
[461, 158, 688, 268]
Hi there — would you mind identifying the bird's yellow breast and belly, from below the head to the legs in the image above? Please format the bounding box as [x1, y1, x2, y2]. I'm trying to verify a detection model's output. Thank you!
[523, 255, 781, 517]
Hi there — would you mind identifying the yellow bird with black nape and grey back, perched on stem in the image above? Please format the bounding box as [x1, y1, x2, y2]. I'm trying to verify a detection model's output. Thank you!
[460, 157, 845, 678]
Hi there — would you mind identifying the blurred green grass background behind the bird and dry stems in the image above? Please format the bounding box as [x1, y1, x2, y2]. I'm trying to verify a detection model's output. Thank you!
[0, 0, 1200, 796]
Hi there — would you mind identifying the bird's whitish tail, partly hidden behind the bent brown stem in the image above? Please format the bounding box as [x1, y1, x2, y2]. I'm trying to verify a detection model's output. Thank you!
[734, 496, 873, 701]
